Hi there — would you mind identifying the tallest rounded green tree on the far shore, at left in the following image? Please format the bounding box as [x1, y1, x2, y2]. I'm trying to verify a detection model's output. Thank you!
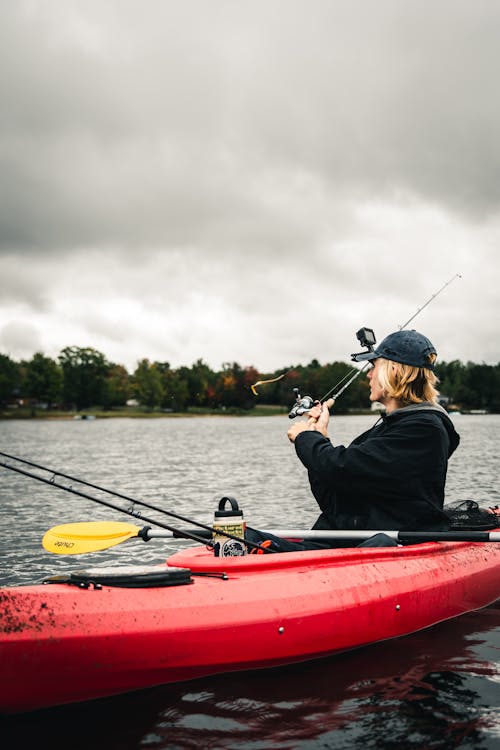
[59, 346, 109, 411]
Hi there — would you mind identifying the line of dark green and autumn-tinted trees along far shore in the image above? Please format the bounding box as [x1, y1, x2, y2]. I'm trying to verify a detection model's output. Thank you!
[0, 346, 500, 413]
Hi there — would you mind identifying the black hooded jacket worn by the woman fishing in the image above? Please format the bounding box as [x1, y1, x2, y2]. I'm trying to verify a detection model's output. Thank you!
[295, 403, 460, 531]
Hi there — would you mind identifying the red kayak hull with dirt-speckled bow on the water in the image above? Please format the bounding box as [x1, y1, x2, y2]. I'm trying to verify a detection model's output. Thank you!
[0, 542, 500, 713]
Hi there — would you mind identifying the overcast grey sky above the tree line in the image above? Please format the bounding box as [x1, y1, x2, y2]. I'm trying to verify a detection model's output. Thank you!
[0, 0, 500, 372]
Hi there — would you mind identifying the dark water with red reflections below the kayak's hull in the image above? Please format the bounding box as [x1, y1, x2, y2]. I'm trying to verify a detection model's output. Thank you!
[3, 607, 500, 750]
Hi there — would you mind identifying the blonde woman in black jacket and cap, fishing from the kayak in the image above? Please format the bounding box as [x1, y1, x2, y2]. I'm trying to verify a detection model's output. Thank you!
[246, 330, 460, 549]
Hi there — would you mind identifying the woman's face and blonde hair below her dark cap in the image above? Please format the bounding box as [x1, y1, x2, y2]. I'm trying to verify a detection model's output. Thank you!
[377, 354, 439, 404]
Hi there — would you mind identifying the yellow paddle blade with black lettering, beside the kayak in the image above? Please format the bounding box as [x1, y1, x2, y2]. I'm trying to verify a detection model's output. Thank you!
[42, 521, 140, 555]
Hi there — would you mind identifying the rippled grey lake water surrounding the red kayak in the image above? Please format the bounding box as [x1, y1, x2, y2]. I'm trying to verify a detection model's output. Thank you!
[0, 415, 500, 750]
